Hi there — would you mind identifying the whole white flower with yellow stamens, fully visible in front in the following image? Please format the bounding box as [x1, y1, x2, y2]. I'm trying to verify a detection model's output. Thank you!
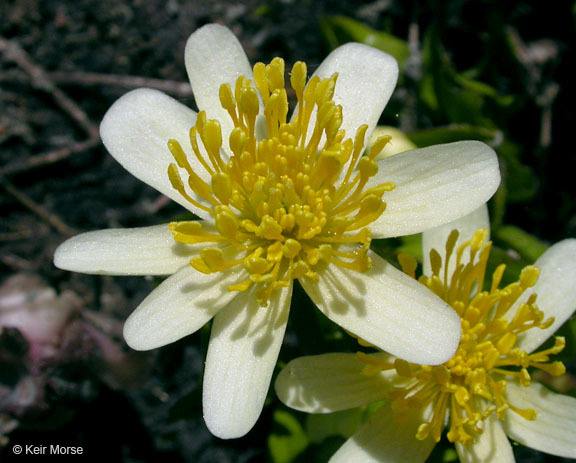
[54, 25, 500, 438]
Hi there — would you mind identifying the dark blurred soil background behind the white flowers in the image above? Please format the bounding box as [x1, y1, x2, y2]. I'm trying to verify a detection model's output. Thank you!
[0, 0, 576, 463]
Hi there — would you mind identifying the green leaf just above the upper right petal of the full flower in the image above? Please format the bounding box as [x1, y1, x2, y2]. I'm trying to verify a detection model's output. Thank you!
[321, 16, 410, 69]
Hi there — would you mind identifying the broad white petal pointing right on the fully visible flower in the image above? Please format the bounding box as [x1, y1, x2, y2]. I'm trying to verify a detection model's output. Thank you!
[366, 141, 500, 238]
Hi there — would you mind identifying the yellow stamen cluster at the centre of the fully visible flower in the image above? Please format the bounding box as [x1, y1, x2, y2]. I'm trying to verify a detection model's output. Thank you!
[168, 58, 394, 305]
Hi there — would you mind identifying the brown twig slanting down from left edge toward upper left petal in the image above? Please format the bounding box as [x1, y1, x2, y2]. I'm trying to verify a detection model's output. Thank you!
[0, 37, 98, 139]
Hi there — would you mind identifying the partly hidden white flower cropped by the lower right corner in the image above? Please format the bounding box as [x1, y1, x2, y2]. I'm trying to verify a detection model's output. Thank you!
[276, 208, 576, 463]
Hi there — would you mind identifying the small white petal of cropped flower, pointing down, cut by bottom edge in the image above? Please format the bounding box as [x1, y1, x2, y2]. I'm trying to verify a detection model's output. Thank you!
[456, 414, 516, 463]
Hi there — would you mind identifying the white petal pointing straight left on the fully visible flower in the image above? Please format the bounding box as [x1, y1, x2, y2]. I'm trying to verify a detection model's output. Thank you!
[54, 224, 198, 275]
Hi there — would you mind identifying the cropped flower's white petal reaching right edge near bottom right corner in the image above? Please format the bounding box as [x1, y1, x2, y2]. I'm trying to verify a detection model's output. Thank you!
[502, 382, 576, 458]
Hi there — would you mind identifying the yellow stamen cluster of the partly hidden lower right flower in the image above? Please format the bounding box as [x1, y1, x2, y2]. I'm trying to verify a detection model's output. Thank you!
[358, 230, 565, 444]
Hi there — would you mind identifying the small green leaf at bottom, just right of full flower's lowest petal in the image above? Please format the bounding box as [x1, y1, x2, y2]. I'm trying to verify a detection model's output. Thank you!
[268, 410, 310, 463]
